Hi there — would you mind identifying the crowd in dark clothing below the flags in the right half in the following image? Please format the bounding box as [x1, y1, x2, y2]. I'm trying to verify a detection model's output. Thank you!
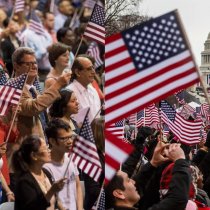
[105, 126, 210, 210]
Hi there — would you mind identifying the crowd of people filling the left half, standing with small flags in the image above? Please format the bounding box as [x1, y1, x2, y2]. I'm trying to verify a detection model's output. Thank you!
[0, 0, 105, 210]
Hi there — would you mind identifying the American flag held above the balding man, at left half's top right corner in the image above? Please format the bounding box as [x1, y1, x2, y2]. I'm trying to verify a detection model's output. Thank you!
[84, 4, 105, 44]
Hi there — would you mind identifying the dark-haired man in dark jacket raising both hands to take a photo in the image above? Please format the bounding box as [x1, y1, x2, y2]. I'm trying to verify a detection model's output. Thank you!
[105, 142, 190, 210]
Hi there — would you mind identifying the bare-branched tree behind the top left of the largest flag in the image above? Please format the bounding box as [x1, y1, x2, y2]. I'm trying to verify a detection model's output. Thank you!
[105, 0, 149, 36]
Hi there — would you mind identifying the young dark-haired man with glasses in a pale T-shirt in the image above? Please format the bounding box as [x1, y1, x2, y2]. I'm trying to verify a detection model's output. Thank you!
[44, 119, 83, 210]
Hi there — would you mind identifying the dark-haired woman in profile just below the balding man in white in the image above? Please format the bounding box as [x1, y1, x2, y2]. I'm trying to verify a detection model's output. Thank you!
[49, 89, 79, 134]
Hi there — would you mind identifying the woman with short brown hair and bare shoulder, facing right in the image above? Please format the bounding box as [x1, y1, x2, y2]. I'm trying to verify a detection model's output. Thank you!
[45, 42, 71, 89]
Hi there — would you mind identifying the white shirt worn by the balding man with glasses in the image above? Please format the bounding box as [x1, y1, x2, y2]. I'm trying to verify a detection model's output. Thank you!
[66, 80, 101, 124]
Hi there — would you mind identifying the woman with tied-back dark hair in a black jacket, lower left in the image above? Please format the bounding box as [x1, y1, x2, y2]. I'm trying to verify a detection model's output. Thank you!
[12, 135, 65, 210]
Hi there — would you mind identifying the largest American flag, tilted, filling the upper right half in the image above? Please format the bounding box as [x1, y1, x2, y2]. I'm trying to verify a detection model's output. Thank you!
[105, 11, 199, 126]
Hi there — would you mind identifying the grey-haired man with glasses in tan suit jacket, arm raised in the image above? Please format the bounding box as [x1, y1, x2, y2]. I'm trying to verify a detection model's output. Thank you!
[3, 47, 71, 144]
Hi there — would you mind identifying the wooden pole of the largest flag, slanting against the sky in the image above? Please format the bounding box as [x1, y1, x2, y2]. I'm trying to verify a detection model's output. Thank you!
[175, 10, 210, 106]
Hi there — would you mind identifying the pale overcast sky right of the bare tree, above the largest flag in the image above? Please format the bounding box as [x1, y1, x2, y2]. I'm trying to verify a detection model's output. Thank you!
[140, 0, 210, 66]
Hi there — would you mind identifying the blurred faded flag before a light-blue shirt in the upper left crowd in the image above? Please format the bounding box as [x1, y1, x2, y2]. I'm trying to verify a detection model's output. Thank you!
[29, 10, 45, 36]
